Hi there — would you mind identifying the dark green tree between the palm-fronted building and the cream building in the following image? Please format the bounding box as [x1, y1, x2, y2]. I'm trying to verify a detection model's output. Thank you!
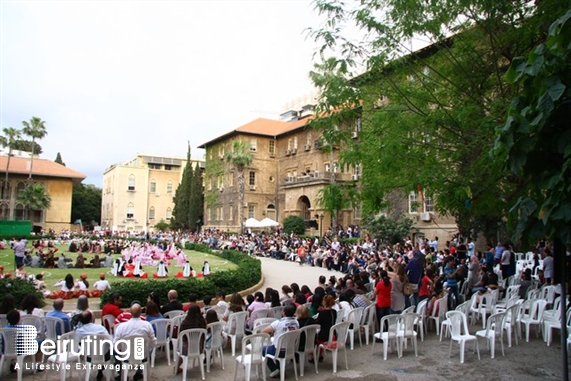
[70, 184, 102, 225]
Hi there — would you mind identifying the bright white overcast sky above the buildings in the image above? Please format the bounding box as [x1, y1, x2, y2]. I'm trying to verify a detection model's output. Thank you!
[0, 0, 320, 187]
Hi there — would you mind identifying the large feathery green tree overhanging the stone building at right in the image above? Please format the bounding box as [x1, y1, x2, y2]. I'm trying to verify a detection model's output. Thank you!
[311, 0, 565, 240]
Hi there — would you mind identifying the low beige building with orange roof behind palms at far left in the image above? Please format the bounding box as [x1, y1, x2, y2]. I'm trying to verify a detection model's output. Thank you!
[0, 156, 85, 232]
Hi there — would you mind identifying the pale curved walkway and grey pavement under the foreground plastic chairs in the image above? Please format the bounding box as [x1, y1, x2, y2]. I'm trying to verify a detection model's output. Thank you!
[17, 258, 561, 381]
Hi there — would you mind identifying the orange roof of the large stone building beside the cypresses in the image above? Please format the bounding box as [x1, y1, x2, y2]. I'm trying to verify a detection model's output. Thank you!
[198, 118, 310, 148]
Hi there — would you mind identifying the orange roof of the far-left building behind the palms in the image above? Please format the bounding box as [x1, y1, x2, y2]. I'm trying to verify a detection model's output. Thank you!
[0, 156, 86, 182]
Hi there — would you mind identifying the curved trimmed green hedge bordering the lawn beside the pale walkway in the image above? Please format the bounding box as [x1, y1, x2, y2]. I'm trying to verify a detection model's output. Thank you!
[101, 244, 262, 308]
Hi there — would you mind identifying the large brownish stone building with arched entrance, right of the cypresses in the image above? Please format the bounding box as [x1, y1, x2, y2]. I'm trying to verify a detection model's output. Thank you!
[199, 108, 457, 242]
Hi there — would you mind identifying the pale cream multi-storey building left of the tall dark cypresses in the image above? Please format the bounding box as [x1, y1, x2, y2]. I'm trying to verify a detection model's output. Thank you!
[101, 154, 202, 232]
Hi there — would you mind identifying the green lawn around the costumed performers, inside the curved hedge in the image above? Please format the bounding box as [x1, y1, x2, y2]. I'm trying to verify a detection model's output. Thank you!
[0, 244, 237, 291]
